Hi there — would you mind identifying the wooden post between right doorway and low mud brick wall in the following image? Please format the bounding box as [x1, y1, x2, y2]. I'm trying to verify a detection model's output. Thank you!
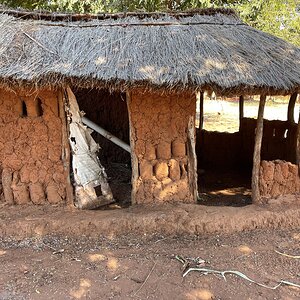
[251, 95, 266, 203]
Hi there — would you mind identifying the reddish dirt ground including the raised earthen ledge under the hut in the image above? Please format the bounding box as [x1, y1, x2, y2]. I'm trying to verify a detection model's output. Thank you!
[0, 198, 300, 300]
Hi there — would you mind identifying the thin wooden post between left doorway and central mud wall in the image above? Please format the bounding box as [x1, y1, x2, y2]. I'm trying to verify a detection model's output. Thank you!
[126, 91, 139, 204]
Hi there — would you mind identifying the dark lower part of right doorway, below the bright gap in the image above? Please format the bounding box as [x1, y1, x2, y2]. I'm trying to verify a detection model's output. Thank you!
[196, 130, 252, 206]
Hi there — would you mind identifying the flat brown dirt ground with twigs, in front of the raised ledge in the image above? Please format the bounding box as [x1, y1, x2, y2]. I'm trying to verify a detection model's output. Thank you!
[0, 228, 300, 300]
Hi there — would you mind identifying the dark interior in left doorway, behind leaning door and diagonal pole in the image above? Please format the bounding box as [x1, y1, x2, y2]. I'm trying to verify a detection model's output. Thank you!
[74, 89, 131, 207]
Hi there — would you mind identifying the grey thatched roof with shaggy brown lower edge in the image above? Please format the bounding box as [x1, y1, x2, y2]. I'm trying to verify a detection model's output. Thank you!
[0, 9, 300, 94]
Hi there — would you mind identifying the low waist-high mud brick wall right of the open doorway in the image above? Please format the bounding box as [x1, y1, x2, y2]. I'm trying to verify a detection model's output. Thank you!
[259, 160, 300, 198]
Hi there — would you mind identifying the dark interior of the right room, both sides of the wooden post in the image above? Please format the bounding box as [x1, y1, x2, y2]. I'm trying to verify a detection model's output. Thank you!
[196, 112, 297, 206]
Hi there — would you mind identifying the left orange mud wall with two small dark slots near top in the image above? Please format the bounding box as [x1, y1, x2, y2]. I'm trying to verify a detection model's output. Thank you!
[0, 89, 65, 204]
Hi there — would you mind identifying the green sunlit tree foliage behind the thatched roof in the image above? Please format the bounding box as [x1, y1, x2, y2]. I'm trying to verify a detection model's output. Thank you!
[0, 0, 300, 46]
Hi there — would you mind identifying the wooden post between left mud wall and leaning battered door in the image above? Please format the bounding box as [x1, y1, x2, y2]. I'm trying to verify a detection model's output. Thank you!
[58, 89, 74, 206]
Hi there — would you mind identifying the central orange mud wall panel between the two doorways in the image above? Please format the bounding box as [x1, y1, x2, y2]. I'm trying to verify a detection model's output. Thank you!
[129, 90, 196, 203]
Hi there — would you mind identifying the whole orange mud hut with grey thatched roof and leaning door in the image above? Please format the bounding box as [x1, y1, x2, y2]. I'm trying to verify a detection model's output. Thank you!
[0, 9, 300, 207]
